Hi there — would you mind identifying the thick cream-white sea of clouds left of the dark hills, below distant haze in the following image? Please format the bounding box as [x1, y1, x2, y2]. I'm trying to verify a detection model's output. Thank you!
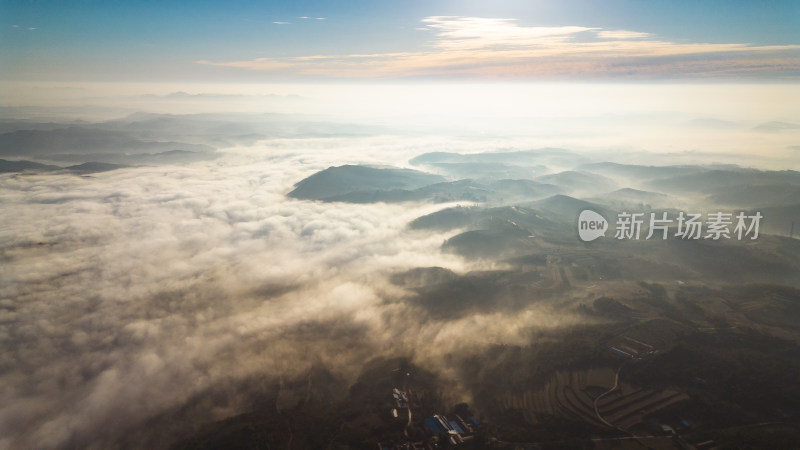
[0, 138, 571, 448]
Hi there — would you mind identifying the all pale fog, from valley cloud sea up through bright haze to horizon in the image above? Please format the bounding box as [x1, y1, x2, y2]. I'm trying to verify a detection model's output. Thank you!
[0, 86, 800, 448]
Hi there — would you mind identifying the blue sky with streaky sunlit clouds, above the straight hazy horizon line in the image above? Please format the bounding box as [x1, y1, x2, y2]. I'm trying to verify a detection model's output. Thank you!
[0, 0, 800, 82]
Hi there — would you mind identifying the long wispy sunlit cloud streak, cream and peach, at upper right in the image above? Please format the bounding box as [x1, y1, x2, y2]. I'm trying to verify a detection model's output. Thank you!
[198, 16, 800, 78]
